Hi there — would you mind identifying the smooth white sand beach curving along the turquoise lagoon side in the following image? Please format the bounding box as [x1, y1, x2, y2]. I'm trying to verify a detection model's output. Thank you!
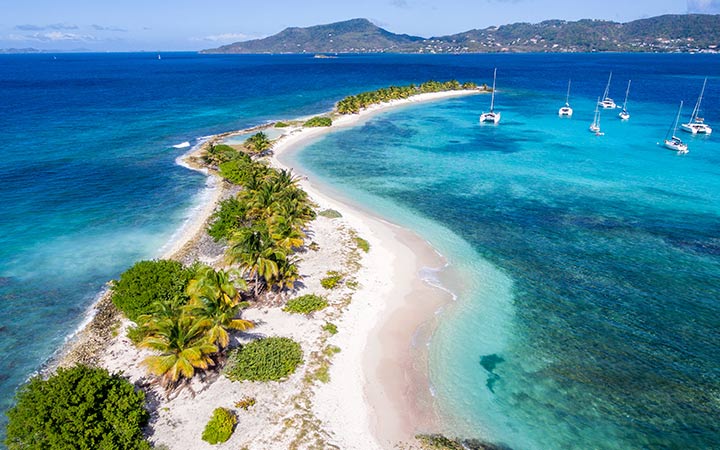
[271, 86, 477, 449]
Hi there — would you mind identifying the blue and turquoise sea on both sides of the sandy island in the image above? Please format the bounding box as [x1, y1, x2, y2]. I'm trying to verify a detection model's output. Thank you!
[0, 53, 720, 449]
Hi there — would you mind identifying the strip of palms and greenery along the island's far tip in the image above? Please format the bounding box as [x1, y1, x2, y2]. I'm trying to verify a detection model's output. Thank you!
[337, 80, 477, 114]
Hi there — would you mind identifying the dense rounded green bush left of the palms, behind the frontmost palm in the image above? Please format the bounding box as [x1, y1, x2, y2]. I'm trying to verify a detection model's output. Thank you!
[112, 259, 194, 321]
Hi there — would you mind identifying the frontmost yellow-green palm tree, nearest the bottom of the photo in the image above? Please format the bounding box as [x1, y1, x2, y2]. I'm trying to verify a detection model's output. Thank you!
[140, 314, 218, 389]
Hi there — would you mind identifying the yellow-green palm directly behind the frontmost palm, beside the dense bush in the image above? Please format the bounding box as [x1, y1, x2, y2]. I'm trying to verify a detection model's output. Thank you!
[186, 266, 255, 349]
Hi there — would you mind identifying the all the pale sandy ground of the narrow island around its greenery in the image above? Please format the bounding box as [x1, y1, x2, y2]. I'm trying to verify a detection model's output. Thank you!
[56, 90, 479, 450]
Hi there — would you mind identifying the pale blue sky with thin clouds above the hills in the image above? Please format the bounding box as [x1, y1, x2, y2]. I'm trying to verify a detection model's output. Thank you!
[0, 0, 720, 51]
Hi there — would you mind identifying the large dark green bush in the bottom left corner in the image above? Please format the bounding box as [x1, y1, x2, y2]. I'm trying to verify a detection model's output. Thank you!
[5, 366, 150, 450]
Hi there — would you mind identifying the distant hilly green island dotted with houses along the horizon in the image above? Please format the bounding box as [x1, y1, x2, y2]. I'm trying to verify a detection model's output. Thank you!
[201, 14, 720, 54]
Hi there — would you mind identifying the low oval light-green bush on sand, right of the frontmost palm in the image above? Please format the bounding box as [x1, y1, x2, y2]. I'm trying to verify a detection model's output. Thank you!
[225, 337, 303, 381]
